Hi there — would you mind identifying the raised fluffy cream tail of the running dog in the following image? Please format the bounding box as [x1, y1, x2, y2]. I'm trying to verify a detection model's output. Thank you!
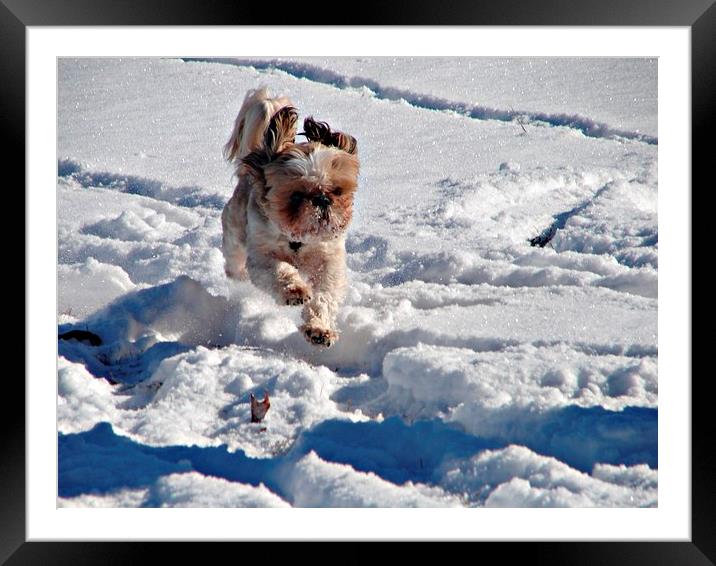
[224, 87, 293, 167]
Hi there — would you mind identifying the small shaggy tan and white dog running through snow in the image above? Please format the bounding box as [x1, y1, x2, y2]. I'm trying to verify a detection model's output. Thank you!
[221, 88, 359, 347]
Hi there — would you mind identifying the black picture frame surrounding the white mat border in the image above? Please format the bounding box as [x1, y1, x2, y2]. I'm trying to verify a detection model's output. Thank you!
[5, 0, 716, 566]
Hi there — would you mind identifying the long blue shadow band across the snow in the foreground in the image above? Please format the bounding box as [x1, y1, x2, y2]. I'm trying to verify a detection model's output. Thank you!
[58, 406, 658, 504]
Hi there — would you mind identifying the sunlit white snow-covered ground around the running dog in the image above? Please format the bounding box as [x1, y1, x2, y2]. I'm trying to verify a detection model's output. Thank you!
[57, 58, 658, 507]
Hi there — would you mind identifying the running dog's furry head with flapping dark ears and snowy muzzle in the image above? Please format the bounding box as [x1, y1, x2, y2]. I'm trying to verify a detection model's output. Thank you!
[243, 107, 359, 243]
